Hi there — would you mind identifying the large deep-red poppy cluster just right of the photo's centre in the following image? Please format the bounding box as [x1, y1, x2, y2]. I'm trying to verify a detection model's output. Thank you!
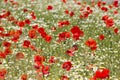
[71, 26, 84, 40]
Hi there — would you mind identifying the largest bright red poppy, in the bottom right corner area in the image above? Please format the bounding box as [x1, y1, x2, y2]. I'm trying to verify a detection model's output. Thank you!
[94, 68, 110, 79]
